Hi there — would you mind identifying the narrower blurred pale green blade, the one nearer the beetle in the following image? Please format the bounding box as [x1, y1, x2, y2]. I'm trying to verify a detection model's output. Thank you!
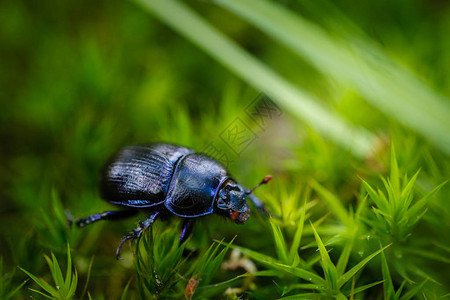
[137, 0, 375, 157]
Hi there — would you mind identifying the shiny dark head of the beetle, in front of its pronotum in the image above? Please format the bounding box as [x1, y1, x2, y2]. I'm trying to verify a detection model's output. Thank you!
[214, 180, 250, 224]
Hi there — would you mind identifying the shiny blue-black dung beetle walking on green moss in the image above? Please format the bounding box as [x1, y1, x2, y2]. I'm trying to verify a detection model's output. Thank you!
[75, 143, 272, 258]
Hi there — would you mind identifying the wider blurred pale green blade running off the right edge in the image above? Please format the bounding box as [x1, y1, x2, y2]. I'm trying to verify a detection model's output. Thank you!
[217, 0, 450, 153]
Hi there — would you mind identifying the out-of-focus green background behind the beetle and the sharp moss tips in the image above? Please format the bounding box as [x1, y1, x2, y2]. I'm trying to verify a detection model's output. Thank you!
[0, 0, 450, 299]
